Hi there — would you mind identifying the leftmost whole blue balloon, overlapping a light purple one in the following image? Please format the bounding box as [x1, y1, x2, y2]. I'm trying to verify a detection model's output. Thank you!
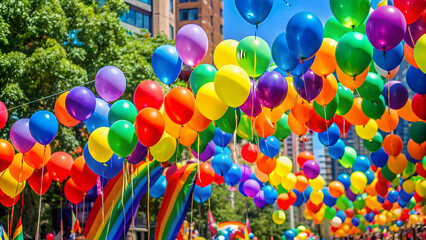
[29, 110, 59, 145]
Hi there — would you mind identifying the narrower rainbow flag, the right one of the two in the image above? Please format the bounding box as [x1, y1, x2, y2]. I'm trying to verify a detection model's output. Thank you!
[155, 163, 198, 240]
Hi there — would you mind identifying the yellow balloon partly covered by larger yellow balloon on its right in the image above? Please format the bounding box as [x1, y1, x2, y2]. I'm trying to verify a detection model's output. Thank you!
[195, 82, 228, 120]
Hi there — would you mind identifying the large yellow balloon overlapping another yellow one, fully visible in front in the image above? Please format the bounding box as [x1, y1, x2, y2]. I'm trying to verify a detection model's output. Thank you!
[213, 65, 251, 110]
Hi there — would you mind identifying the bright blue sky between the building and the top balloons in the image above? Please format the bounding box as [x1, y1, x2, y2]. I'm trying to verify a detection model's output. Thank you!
[223, 0, 379, 46]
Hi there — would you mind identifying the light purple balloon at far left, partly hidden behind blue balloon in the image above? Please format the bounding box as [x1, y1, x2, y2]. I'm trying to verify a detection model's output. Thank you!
[10, 118, 36, 153]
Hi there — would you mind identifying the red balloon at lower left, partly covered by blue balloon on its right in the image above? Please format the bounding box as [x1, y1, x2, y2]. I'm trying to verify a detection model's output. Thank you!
[70, 156, 98, 192]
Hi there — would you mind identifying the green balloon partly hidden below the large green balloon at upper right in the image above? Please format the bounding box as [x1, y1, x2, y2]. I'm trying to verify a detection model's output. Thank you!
[356, 72, 384, 101]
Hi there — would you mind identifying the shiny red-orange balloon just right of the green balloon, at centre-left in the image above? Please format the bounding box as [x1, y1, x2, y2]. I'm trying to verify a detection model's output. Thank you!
[134, 107, 165, 147]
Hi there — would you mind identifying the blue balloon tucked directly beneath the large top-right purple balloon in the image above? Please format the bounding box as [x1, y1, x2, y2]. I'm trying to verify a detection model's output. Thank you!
[373, 43, 404, 71]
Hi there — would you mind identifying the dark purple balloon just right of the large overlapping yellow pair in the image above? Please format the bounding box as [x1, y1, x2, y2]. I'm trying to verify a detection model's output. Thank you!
[256, 71, 288, 108]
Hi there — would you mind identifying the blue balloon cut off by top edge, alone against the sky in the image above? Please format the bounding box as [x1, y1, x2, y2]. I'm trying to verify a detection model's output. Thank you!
[235, 0, 274, 25]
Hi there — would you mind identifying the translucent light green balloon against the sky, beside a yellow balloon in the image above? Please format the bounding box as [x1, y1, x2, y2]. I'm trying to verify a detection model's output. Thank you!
[237, 36, 271, 77]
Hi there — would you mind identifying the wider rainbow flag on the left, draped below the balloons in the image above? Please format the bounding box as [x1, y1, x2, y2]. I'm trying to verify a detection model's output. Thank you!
[83, 161, 163, 239]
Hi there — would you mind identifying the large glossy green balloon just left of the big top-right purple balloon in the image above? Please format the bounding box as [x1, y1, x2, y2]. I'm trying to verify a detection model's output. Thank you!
[336, 31, 373, 77]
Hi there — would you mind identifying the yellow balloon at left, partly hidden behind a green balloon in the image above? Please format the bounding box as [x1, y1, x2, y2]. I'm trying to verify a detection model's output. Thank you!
[88, 127, 113, 163]
